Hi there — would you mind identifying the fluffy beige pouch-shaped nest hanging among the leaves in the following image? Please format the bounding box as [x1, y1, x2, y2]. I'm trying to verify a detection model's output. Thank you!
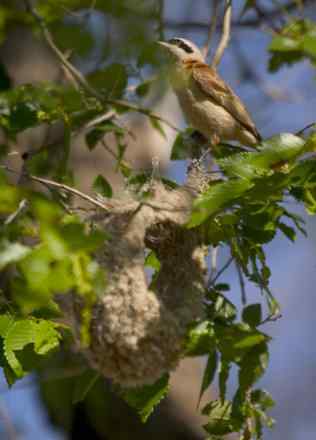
[63, 164, 211, 386]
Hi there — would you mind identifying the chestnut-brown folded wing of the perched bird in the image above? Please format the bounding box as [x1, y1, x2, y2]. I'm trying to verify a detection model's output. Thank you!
[192, 63, 261, 141]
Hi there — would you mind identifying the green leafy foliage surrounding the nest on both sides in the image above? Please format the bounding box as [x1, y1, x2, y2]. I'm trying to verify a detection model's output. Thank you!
[0, 0, 316, 440]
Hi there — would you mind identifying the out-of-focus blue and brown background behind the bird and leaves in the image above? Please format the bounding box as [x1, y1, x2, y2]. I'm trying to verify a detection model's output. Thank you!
[0, 0, 316, 440]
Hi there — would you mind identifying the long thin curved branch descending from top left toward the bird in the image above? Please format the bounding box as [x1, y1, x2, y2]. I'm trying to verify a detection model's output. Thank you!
[24, 0, 181, 132]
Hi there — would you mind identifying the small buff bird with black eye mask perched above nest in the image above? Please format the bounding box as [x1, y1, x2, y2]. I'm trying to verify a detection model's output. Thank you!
[158, 38, 261, 146]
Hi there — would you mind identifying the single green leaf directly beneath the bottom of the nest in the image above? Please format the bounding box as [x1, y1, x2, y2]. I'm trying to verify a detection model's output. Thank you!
[122, 374, 169, 423]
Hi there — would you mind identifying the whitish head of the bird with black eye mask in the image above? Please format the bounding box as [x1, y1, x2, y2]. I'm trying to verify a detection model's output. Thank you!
[158, 38, 204, 62]
